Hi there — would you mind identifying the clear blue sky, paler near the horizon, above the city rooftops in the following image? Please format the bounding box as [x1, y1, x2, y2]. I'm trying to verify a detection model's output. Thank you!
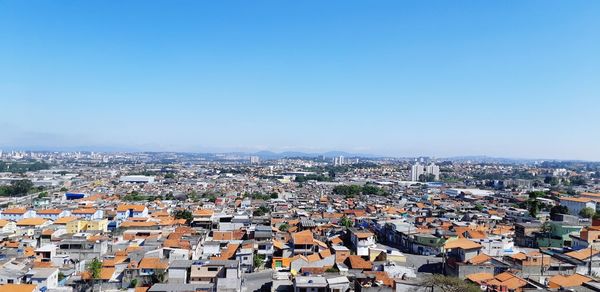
[0, 0, 600, 160]
